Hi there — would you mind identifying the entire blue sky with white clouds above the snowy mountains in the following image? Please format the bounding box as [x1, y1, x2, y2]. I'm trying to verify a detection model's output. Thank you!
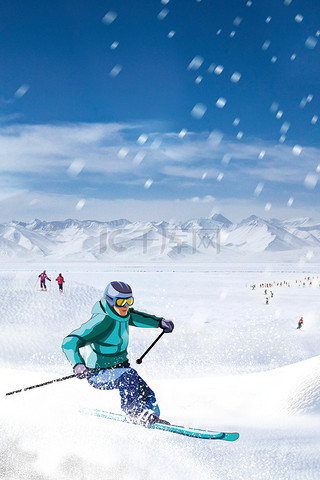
[0, 0, 320, 220]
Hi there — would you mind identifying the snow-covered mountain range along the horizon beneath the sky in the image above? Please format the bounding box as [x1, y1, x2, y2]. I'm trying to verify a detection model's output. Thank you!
[0, 214, 320, 263]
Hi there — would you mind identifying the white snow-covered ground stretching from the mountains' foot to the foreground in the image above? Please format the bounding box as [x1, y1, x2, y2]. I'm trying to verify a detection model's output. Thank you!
[0, 264, 320, 480]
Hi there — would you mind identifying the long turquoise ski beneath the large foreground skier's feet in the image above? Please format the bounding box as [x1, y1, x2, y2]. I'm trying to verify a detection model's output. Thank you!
[81, 409, 239, 442]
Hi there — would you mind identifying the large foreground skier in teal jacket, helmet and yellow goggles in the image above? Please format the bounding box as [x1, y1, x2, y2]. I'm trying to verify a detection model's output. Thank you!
[62, 281, 174, 425]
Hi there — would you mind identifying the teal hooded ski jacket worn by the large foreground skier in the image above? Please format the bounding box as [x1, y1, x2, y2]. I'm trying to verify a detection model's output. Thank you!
[62, 298, 162, 370]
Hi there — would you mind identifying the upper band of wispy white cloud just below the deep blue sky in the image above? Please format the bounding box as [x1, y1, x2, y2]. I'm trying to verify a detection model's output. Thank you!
[0, 123, 320, 183]
